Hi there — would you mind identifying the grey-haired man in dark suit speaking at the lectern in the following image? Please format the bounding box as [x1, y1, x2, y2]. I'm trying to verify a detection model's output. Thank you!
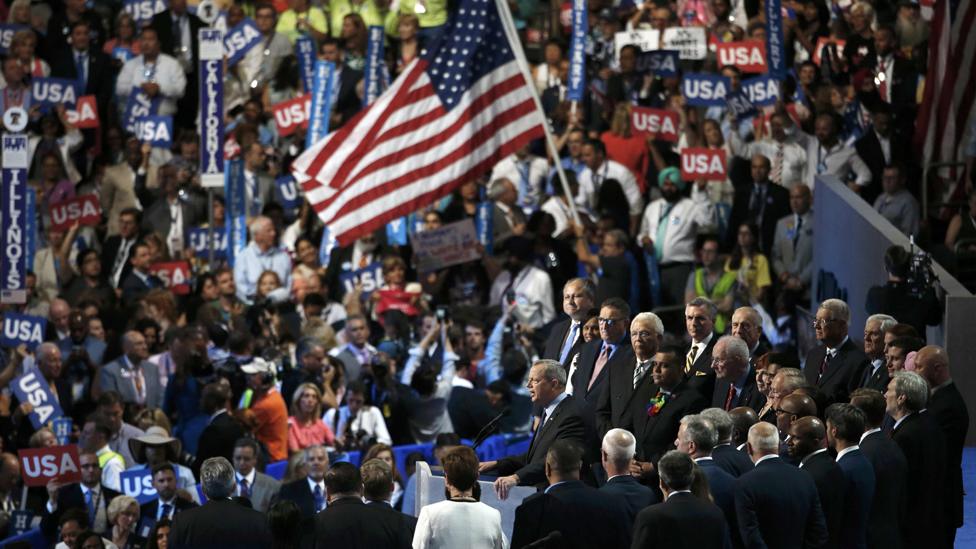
[479, 359, 584, 499]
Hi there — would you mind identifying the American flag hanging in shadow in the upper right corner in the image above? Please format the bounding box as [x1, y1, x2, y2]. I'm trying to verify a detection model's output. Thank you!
[915, 0, 976, 209]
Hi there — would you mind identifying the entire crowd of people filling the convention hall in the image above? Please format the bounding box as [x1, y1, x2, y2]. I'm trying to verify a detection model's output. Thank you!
[0, 0, 976, 549]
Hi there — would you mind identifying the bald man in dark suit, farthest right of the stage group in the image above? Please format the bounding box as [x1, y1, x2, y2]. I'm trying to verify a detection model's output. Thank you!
[915, 345, 969, 547]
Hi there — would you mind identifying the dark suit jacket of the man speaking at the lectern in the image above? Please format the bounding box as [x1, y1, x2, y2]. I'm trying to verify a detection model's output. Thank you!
[498, 395, 584, 485]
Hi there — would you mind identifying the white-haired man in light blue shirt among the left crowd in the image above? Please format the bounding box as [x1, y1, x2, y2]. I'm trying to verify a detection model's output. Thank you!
[234, 215, 291, 305]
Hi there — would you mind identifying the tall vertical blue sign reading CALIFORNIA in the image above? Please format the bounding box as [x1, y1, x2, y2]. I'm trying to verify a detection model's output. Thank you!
[199, 29, 224, 187]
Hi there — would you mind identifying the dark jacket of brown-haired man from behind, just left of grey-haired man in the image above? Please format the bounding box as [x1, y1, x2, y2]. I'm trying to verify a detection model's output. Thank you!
[861, 431, 908, 549]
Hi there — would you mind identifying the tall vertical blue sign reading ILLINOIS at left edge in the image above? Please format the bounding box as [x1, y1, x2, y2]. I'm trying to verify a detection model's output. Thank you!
[0, 134, 30, 303]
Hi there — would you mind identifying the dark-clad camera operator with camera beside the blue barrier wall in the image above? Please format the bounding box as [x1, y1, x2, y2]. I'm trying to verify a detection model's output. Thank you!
[866, 245, 942, 334]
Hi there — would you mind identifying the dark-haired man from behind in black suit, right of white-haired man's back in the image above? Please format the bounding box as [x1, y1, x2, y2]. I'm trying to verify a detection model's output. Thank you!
[633, 451, 732, 548]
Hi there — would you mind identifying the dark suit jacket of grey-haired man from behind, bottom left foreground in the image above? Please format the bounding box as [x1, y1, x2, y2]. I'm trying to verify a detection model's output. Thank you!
[169, 499, 271, 549]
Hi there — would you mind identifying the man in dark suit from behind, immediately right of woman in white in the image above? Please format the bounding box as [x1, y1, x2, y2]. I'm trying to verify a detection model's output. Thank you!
[512, 440, 630, 549]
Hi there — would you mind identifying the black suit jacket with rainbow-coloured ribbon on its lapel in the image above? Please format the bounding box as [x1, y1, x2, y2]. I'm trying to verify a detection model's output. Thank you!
[631, 383, 708, 463]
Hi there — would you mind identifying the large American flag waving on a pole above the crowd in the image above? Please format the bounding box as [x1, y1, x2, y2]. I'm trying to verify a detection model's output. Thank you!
[292, 0, 545, 245]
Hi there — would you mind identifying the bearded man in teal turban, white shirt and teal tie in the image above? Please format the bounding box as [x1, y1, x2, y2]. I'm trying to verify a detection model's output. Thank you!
[637, 166, 715, 305]
